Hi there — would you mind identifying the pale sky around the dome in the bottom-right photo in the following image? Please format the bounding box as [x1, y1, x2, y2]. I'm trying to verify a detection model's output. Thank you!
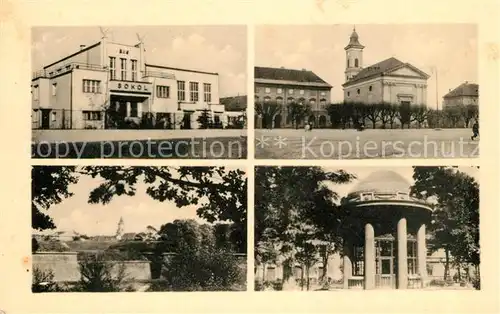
[324, 166, 479, 198]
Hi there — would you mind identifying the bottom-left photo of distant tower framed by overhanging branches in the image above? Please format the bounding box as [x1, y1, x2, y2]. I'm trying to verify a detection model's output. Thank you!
[31, 166, 247, 293]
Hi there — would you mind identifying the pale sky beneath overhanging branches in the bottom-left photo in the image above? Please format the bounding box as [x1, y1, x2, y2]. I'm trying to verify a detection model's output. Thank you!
[35, 167, 246, 236]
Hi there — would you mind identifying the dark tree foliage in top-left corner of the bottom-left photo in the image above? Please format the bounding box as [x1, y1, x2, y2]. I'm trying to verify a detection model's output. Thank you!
[31, 166, 78, 230]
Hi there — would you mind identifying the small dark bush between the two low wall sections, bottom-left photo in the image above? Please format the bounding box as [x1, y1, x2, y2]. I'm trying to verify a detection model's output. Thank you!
[76, 254, 126, 292]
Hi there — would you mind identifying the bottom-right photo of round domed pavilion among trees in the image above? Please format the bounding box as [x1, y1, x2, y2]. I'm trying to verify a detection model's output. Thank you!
[254, 166, 480, 291]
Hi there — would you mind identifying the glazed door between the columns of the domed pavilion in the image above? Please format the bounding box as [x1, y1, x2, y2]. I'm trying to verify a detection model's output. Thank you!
[375, 239, 396, 289]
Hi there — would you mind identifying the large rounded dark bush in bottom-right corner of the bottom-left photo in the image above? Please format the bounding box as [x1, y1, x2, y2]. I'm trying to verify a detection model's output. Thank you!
[163, 244, 246, 291]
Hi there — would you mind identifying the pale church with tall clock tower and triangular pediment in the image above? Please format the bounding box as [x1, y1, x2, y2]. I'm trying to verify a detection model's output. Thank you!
[342, 28, 430, 105]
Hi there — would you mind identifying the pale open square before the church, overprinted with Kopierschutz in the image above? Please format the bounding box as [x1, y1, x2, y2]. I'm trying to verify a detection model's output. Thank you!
[255, 129, 479, 159]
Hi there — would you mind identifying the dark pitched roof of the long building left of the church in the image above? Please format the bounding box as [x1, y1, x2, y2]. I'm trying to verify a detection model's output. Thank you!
[254, 67, 331, 87]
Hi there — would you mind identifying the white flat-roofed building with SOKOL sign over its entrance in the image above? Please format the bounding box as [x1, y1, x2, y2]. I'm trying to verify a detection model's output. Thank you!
[31, 36, 227, 129]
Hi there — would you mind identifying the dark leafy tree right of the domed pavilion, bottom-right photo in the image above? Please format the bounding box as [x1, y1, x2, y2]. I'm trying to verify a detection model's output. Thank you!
[411, 167, 480, 279]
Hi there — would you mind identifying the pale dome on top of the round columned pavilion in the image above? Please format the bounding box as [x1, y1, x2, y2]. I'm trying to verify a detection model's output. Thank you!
[349, 170, 410, 194]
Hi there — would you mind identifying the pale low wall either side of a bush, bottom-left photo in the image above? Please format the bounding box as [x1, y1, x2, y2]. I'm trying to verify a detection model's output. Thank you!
[32, 252, 151, 282]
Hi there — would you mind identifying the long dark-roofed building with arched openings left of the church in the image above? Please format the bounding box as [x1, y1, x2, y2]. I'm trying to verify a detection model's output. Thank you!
[254, 67, 332, 128]
